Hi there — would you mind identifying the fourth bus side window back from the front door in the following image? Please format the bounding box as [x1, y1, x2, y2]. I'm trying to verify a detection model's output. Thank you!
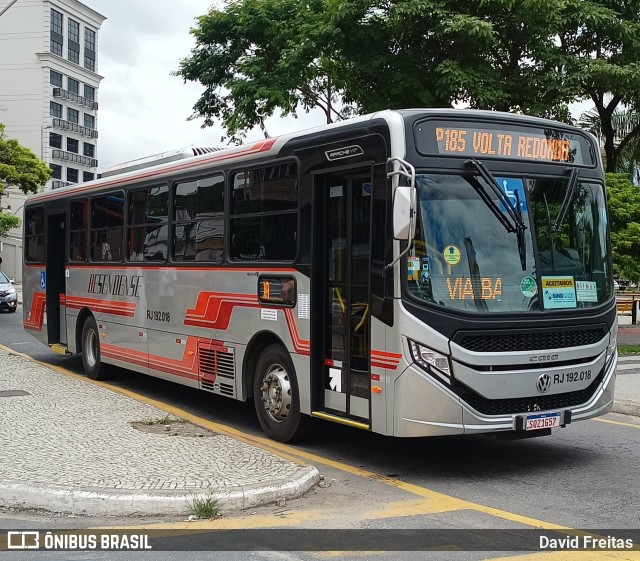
[90, 191, 124, 262]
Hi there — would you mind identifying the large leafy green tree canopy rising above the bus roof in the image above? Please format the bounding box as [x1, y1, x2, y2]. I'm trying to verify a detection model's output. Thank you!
[176, 0, 640, 144]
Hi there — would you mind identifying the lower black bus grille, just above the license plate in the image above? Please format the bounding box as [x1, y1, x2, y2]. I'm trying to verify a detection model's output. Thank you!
[459, 370, 604, 415]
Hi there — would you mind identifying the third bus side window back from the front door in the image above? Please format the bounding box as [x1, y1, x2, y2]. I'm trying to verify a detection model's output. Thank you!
[127, 185, 169, 261]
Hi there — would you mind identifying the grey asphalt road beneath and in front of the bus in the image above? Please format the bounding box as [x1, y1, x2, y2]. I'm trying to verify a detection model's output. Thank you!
[0, 310, 640, 559]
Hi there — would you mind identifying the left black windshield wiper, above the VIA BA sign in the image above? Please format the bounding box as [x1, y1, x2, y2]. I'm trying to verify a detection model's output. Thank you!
[466, 158, 528, 271]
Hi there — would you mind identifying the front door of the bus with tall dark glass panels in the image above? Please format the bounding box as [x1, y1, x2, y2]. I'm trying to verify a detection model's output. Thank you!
[312, 168, 373, 428]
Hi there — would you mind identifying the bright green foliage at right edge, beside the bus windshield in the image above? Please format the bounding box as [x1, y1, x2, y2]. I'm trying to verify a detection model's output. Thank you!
[606, 173, 640, 282]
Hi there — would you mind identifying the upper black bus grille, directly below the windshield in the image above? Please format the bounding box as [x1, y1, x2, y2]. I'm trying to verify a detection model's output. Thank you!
[454, 327, 606, 353]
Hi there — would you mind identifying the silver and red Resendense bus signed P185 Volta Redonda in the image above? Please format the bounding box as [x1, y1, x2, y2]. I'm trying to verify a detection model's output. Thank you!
[23, 109, 617, 442]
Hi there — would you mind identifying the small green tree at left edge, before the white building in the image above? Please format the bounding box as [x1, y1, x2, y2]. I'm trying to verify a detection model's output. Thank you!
[0, 123, 51, 236]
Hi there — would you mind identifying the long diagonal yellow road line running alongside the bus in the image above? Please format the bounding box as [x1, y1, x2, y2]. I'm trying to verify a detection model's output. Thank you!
[0, 345, 632, 535]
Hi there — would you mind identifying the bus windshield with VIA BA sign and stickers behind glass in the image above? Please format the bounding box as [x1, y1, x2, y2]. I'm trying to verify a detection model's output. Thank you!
[407, 170, 613, 313]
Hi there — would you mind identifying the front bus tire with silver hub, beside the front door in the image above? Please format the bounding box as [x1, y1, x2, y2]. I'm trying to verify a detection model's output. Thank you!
[253, 344, 309, 442]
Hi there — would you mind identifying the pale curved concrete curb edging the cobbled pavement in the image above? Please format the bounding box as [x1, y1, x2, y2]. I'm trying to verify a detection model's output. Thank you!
[0, 466, 320, 516]
